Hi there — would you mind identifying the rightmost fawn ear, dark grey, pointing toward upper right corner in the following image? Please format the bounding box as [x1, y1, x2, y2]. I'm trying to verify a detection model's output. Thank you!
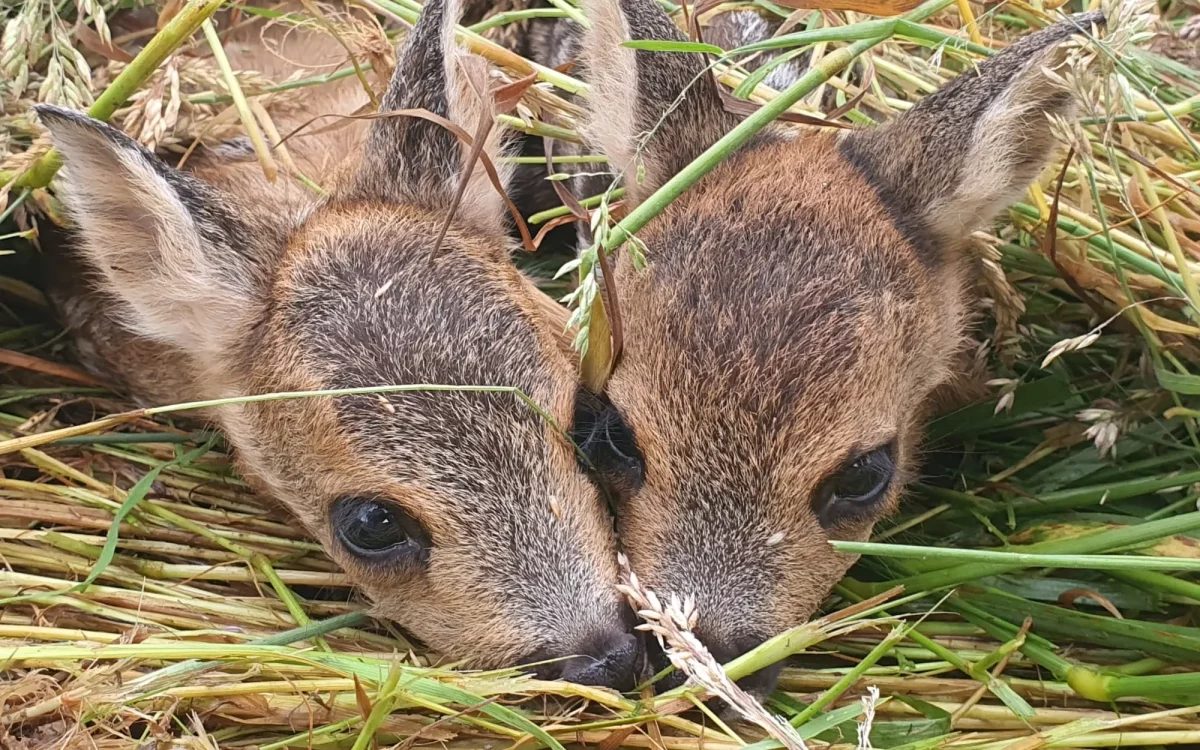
[839, 12, 1104, 256]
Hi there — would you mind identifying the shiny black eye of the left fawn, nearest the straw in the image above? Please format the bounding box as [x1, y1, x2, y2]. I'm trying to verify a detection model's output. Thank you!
[329, 497, 431, 564]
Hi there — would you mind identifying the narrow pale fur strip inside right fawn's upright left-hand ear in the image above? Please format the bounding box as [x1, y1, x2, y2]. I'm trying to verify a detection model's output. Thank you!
[582, 0, 638, 173]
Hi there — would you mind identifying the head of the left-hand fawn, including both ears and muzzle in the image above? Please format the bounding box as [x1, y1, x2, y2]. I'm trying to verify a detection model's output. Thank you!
[38, 0, 636, 686]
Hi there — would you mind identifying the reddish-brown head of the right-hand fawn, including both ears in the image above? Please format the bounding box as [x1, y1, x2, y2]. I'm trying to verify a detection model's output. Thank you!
[571, 0, 1103, 686]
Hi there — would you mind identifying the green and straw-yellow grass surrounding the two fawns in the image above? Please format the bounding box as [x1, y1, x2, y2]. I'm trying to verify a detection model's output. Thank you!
[0, 0, 1200, 750]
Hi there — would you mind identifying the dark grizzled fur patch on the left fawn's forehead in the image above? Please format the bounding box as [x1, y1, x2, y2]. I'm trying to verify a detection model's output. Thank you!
[282, 226, 548, 494]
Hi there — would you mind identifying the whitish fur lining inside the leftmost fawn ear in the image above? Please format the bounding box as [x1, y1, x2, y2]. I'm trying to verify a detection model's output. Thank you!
[52, 122, 258, 354]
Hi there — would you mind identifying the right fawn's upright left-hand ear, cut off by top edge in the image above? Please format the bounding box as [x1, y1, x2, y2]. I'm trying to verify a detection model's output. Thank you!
[581, 0, 738, 203]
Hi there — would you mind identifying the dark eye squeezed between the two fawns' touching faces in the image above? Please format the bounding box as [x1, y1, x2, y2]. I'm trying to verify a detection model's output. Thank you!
[571, 389, 646, 496]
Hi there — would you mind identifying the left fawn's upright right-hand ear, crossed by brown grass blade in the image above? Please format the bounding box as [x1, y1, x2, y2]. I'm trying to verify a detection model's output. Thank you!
[343, 0, 508, 233]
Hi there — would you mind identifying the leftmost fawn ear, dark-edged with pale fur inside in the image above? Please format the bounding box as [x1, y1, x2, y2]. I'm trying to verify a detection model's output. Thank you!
[36, 104, 270, 354]
